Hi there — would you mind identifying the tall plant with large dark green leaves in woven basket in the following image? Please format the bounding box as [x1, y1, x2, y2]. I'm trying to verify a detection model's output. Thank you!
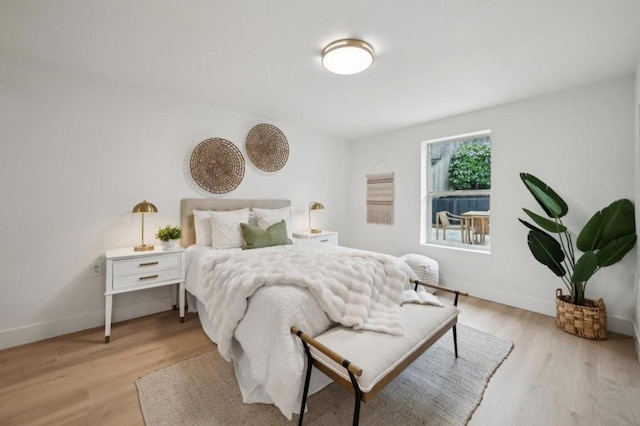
[518, 173, 637, 340]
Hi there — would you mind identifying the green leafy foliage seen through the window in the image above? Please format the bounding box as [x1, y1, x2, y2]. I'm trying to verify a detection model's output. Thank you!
[449, 144, 491, 190]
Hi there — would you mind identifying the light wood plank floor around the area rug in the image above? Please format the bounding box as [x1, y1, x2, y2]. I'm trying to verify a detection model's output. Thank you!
[0, 296, 640, 426]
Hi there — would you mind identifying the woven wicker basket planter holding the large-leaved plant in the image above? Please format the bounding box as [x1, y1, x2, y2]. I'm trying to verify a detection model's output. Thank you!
[556, 289, 607, 340]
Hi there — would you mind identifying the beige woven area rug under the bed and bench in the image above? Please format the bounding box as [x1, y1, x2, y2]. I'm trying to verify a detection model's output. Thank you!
[136, 324, 513, 426]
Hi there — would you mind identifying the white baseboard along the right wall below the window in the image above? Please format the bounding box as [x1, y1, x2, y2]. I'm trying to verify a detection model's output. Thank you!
[440, 279, 638, 338]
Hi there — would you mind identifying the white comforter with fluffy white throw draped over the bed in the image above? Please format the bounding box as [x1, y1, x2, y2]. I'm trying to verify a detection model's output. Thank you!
[188, 243, 410, 419]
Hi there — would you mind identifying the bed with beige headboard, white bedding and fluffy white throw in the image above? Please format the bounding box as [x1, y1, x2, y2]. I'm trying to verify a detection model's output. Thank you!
[181, 199, 420, 419]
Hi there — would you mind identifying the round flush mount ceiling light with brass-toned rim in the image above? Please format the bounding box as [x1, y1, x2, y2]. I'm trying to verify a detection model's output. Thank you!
[322, 39, 374, 75]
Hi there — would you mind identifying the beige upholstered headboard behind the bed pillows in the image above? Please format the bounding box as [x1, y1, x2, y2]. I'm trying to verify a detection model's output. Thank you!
[181, 198, 291, 247]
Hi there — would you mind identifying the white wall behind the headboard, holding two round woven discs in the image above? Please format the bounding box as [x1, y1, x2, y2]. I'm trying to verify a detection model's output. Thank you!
[0, 56, 348, 349]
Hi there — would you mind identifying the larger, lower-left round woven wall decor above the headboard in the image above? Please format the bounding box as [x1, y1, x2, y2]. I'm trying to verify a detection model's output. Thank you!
[189, 138, 244, 194]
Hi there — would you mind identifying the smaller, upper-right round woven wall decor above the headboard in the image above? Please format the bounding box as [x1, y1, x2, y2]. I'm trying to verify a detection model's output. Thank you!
[246, 124, 289, 172]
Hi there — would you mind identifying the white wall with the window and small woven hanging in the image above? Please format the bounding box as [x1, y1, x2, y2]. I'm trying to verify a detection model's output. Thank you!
[349, 77, 637, 335]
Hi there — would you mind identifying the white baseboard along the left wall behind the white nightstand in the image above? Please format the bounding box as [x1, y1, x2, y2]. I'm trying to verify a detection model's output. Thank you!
[0, 297, 173, 350]
